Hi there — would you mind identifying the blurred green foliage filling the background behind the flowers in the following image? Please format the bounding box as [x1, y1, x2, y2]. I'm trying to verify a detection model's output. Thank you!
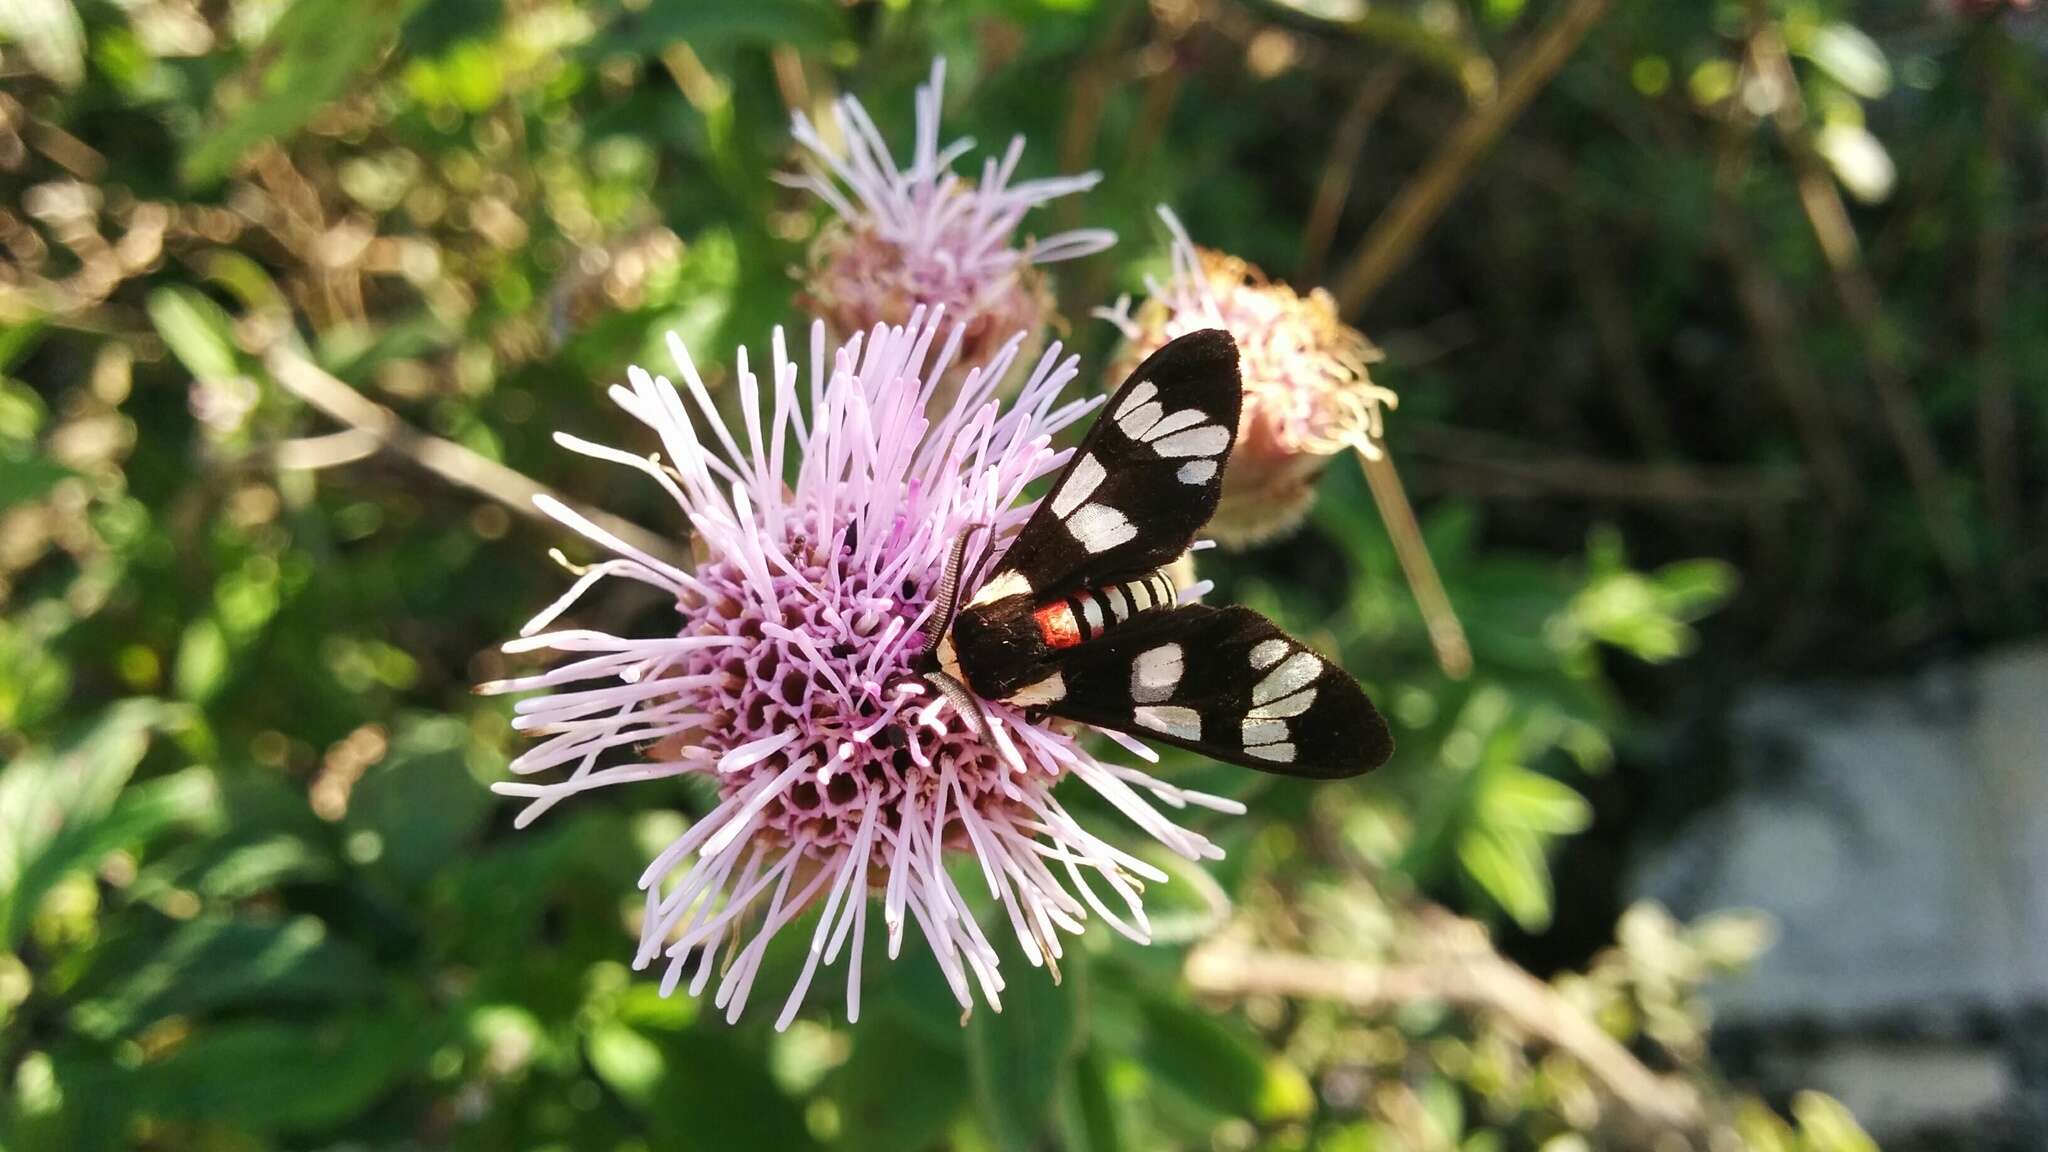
[0, 0, 2048, 1152]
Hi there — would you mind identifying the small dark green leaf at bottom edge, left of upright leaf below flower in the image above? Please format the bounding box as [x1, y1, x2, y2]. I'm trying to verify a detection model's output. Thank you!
[831, 1011, 971, 1152]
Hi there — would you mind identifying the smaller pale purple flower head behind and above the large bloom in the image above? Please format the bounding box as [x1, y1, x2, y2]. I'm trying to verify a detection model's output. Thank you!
[793, 59, 1116, 375]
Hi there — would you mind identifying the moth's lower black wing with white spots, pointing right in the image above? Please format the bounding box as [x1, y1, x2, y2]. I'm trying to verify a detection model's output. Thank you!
[1049, 605, 1395, 779]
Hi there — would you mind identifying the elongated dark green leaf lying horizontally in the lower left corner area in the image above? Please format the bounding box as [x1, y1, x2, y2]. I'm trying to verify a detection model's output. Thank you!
[74, 916, 377, 1037]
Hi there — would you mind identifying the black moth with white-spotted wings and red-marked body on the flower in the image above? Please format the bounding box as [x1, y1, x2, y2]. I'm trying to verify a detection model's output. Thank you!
[915, 328, 1393, 779]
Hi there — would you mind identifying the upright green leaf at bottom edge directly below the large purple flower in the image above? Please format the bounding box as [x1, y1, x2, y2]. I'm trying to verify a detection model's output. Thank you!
[967, 924, 1081, 1150]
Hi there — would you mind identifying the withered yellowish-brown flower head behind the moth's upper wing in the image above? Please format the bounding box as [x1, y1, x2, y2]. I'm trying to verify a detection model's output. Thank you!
[1100, 207, 1397, 547]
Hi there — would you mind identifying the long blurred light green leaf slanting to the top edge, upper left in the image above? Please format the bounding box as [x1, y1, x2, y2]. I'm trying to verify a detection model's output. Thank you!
[178, 0, 418, 184]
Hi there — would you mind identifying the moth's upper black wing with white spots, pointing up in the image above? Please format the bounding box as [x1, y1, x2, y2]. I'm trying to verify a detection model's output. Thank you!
[985, 328, 1243, 596]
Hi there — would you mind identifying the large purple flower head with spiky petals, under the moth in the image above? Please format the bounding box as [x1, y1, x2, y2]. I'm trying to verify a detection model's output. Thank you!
[483, 310, 1241, 1027]
